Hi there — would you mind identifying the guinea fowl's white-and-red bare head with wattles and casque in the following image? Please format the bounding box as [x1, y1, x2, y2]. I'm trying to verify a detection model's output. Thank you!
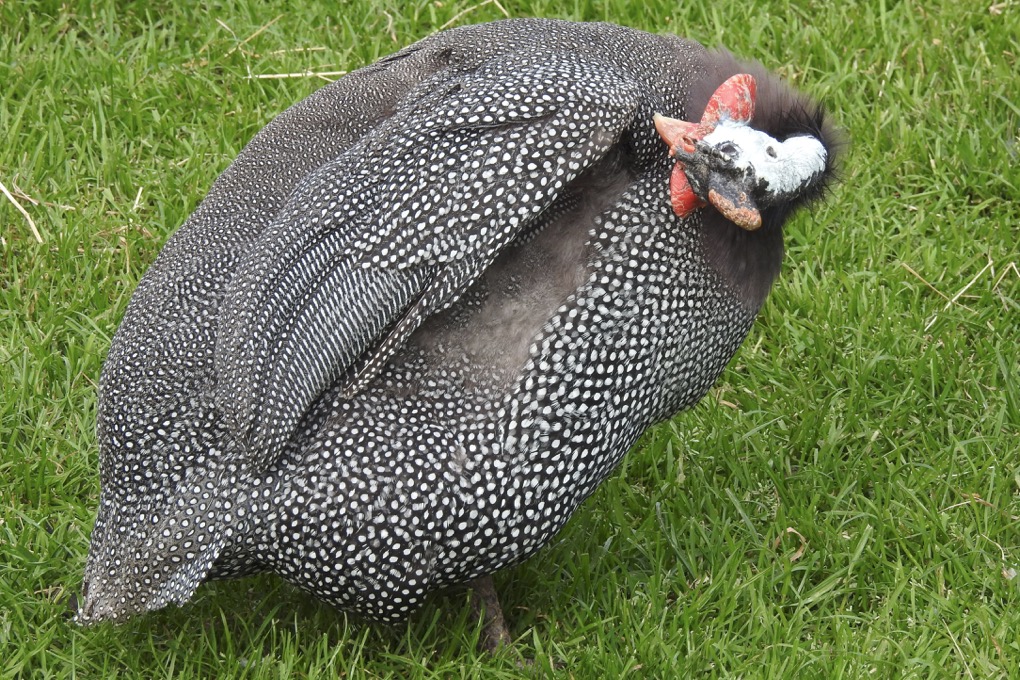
[655, 73, 829, 231]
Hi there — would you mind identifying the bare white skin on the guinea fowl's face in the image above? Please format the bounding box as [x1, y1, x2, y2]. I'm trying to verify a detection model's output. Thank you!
[704, 120, 826, 196]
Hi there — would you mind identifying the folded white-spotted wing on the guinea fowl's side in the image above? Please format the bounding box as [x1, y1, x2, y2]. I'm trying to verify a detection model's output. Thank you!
[215, 53, 651, 469]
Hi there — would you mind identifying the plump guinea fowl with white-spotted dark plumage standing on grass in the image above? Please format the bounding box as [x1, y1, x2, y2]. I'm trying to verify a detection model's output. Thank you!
[78, 19, 833, 644]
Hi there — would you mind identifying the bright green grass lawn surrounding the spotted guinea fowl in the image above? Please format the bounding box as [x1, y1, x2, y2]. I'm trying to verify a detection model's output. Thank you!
[0, 0, 1020, 678]
